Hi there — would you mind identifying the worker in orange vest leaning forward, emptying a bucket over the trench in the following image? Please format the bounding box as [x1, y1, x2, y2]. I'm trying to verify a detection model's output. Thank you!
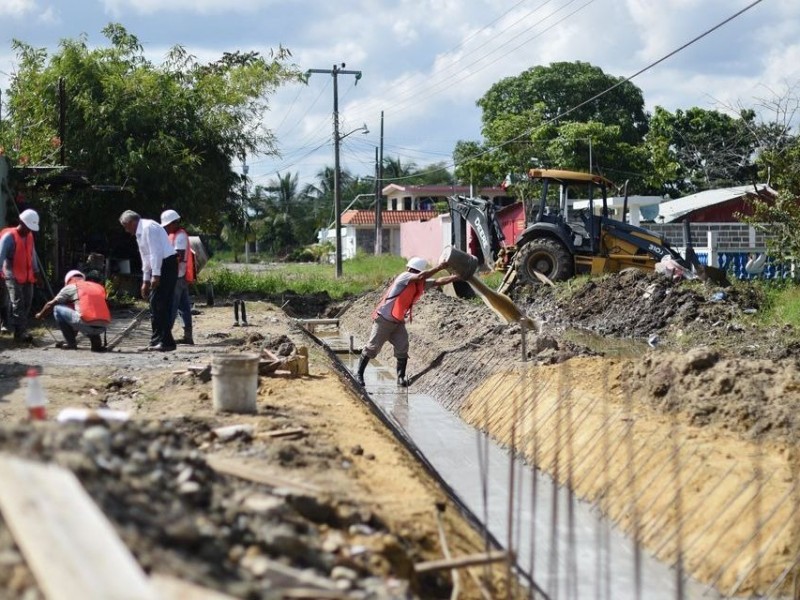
[356, 257, 460, 387]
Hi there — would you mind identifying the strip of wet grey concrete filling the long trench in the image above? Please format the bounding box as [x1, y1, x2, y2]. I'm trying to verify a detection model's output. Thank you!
[330, 339, 720, 600]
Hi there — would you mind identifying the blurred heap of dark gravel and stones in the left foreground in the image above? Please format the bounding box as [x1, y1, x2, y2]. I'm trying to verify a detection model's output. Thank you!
[0, 419, 418, 598]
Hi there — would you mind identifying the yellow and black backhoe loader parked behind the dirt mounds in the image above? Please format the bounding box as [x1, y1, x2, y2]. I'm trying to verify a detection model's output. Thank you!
[450, 169, 727, 292]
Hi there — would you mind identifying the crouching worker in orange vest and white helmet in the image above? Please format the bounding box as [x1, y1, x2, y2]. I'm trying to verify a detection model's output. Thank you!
[36, 270, 111, 352]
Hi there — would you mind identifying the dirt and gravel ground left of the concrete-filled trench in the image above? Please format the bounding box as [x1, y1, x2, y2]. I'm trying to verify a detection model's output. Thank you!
[0, 301, 504, 598]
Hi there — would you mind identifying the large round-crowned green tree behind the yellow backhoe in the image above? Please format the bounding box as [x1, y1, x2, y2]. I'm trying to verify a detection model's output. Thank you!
[454, 62, 648, 192]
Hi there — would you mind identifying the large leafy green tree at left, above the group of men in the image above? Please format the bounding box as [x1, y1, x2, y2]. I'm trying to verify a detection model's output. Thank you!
[3, 24, 300, 231]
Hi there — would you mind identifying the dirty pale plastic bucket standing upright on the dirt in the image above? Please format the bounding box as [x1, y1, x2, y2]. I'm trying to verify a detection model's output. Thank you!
[211, 354, 258, 413]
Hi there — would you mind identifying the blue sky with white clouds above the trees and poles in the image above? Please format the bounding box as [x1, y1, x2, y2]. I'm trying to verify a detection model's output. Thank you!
[0, 0, 800, 190]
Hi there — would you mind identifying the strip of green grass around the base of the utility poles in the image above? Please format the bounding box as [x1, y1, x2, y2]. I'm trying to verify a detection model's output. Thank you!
[200, 255, 405, 300]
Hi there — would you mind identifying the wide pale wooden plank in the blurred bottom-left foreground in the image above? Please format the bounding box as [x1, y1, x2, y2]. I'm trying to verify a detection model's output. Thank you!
[0, 454, 158, 600]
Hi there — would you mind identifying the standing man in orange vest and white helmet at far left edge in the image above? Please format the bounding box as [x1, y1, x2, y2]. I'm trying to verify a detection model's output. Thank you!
[0, 208, 39, 343]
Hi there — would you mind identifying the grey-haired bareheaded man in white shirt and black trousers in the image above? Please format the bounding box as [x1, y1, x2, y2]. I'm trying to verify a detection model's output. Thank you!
[119, 210, 178, 352]
